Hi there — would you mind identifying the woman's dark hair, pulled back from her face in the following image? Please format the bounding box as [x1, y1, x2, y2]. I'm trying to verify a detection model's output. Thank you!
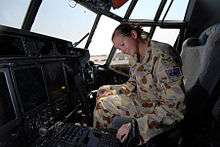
[112, 23, 150, 40]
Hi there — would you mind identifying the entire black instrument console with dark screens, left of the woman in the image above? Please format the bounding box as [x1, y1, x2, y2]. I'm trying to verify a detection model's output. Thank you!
[0, 26, 129, 147]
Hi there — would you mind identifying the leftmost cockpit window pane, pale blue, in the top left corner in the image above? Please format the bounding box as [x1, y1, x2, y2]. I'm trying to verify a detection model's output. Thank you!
[0, 0, 31, 28]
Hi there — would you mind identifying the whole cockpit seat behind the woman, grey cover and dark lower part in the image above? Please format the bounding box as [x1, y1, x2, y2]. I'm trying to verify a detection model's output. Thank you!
[181, 24, 220, 147]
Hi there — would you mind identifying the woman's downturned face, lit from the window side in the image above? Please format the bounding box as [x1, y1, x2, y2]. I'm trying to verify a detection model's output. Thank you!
[112, 32, 138, 56]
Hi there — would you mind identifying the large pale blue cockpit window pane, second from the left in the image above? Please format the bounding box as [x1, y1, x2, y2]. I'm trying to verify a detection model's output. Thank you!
[31, 0, 96, 48]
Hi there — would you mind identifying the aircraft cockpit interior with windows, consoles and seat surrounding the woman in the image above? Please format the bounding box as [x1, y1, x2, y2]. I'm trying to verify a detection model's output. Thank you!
[0, 0, 220, 147]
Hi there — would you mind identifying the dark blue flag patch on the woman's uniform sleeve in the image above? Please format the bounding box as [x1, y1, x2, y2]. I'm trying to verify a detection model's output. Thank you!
[166, 67, 183, 81]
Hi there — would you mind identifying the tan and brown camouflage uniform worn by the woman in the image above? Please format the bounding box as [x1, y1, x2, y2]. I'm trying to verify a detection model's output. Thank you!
[93, 41, 185, 143]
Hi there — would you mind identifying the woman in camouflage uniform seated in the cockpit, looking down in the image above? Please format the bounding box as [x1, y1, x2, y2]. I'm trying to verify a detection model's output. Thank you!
[93, 23, 185, 144]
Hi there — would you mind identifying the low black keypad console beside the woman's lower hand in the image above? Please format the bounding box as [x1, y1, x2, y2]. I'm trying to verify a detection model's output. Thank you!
[34, 122, 122, 147]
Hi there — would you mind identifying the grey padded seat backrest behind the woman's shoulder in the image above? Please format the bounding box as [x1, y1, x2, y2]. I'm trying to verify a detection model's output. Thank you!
[181, 24, 220, 94]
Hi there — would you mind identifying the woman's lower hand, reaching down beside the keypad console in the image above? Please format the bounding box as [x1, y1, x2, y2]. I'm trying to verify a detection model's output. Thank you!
[116, 123, 131, 142]
